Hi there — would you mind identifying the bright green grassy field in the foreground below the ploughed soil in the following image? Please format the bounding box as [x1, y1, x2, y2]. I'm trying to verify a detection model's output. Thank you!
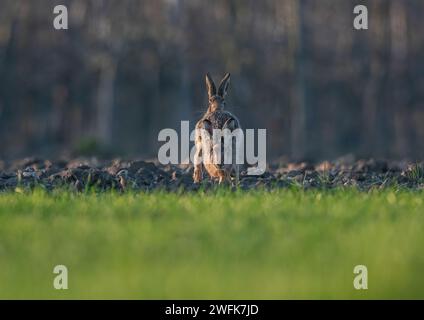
[0, 190, 424, 299]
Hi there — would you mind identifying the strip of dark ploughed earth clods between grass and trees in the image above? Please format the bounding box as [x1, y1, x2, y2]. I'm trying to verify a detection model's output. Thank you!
[0, 157, 424, 192]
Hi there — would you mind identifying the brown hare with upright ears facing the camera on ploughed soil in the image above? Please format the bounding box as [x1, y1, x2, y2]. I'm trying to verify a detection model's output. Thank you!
[193, 73, 241, 185]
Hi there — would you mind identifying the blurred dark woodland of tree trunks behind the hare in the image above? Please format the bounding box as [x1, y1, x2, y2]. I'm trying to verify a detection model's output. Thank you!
[0, 0, 424, 159]
